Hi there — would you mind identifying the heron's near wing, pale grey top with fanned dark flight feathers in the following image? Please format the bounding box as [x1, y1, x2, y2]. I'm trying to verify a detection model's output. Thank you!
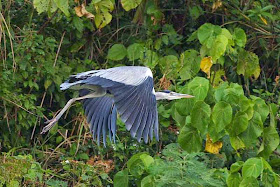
[83, 66, 159, 143]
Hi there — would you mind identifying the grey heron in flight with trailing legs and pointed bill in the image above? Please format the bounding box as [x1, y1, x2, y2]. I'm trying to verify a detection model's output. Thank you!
[41, 66, 193, 146]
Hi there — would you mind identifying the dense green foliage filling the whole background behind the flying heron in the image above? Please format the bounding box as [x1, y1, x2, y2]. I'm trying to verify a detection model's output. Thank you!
[0, 0, 280, 186]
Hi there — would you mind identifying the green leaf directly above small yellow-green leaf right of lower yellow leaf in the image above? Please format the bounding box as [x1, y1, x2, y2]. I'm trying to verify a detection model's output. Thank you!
[226, 112, 248, 136]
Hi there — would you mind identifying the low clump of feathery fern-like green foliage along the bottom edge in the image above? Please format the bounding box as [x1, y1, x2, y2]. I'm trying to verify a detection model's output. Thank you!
[114, 144, 227, 187]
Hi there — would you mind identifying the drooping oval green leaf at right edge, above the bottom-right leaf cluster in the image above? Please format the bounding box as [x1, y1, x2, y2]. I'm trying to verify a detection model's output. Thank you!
[259, 126, 279, 158]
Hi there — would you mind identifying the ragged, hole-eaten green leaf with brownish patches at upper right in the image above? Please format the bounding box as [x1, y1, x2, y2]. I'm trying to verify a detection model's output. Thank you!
[237, 50, 261, 79]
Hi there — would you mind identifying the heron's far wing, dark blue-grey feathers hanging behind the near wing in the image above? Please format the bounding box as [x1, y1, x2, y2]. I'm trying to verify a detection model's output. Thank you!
[80, 90, 117, 147]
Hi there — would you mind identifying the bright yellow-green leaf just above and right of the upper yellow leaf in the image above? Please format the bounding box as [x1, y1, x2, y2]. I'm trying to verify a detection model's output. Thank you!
[209, 35, 228, 62]
